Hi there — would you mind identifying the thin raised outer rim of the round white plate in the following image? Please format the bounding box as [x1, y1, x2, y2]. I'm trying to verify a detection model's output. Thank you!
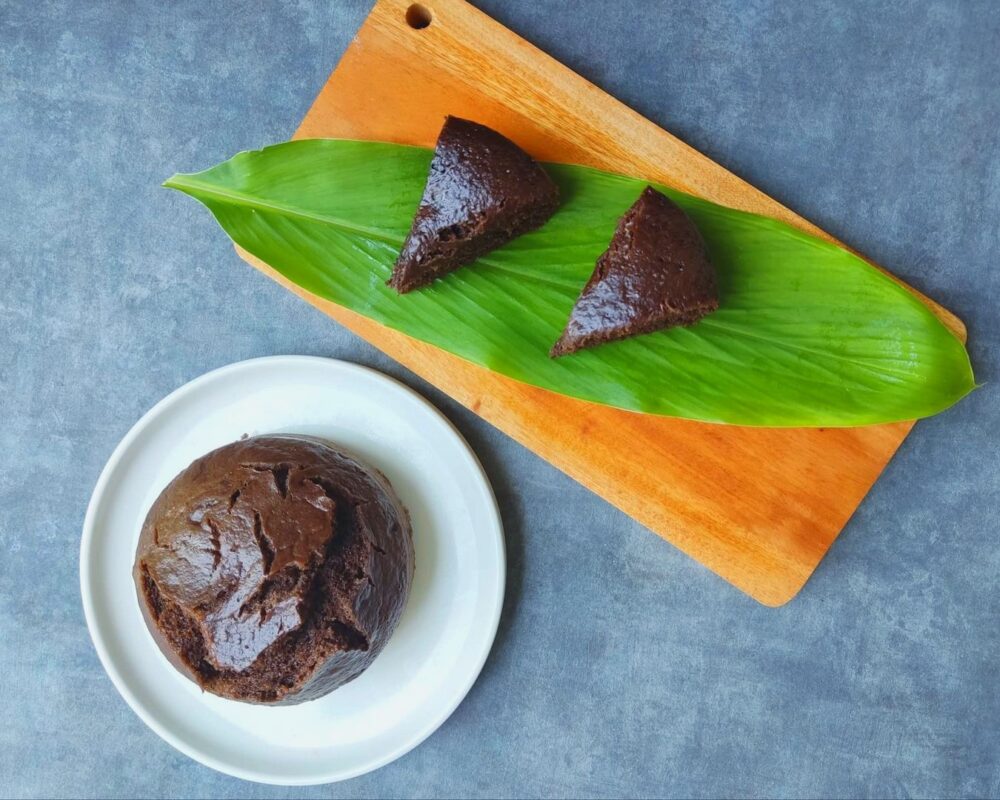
[79, 355, 507, 786]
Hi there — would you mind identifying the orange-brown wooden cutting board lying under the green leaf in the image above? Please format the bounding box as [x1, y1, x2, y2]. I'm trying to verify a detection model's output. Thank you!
[234, 0, 965, 606]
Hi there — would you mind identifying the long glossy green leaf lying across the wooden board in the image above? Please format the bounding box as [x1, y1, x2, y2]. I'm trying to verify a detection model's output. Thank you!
[165, 139, 974, 426]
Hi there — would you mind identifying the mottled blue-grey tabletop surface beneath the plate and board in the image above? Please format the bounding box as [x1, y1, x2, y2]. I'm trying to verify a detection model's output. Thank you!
[0, 0, 1000, 797]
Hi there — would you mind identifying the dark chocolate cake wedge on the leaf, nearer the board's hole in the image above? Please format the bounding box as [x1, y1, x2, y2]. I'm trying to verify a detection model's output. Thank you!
[389, 117, 559, 294]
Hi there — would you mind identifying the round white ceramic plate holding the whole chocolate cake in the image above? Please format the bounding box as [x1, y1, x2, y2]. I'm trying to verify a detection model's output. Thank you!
[80, 356, 505, 785]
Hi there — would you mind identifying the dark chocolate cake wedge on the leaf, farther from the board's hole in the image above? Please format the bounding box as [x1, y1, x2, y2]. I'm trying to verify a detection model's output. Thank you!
[550, 186, 719, 357]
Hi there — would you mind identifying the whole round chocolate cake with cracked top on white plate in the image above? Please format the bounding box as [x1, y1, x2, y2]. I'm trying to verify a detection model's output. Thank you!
[134, 436, 413, 704]
